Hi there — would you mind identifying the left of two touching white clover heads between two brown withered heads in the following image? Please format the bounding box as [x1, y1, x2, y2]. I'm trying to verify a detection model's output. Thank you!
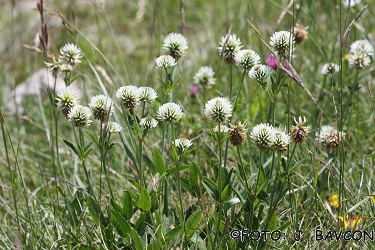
[250, 123, 276, 150]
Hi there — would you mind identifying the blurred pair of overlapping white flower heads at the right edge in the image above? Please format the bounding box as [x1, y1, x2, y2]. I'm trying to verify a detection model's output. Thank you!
[348, 40, 374, 70]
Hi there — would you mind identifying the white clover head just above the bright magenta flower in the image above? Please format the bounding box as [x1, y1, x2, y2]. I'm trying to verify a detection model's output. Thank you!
[270, 31, 295, 59]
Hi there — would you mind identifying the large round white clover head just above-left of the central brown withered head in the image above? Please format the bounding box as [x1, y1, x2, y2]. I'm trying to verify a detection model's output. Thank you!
[204, 97, 233, 123]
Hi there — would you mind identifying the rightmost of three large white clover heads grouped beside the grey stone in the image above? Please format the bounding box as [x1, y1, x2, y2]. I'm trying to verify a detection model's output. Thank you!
[89, 95, 113, 122]
